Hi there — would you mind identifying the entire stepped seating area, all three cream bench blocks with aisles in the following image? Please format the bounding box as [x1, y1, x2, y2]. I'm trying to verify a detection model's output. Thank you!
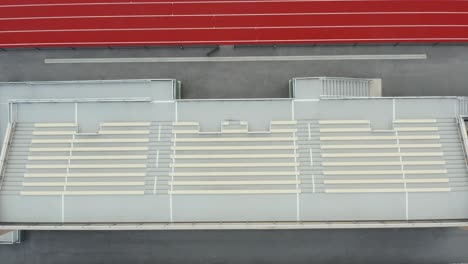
[1, 119, 467, 195]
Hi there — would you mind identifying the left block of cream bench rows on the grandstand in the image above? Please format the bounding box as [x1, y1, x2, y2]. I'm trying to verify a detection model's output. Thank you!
[21, 122, 150, 195]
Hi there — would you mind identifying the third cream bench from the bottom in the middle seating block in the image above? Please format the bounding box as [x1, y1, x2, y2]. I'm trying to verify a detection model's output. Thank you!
[170, 171, 296, 177]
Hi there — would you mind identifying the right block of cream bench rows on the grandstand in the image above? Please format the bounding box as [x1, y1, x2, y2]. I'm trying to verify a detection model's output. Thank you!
[319, 119, 450, 193]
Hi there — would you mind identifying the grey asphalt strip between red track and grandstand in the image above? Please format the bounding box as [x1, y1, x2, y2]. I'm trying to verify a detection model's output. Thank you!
[0, 45, 468, 98]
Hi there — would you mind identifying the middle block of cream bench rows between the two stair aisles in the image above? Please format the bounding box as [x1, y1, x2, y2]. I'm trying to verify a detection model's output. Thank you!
[169, 121, 300, 194]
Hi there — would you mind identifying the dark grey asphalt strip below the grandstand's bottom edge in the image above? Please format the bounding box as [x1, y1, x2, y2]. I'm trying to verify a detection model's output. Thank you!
[0, 229, 468, 264]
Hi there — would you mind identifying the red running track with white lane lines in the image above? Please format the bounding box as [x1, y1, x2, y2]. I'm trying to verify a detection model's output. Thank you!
[0, 0, 468, 48]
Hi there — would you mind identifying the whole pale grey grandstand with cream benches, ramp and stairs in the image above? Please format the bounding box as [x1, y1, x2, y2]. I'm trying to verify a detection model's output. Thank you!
[0, 78, 468, 228]
